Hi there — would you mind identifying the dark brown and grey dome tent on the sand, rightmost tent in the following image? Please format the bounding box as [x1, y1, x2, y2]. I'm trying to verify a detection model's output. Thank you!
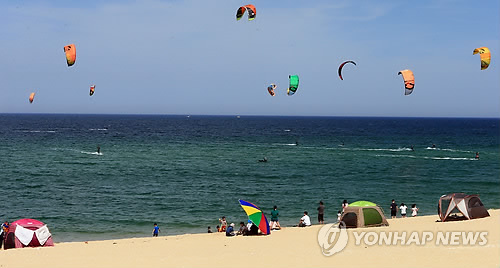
[438, 193, 490, 221]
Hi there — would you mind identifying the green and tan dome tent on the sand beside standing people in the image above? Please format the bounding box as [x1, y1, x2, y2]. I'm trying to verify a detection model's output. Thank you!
[340, 201, 389, 228]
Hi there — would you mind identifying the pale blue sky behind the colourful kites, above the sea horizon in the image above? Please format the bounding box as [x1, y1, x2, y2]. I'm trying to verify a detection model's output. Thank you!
[0, 0, 500, 117]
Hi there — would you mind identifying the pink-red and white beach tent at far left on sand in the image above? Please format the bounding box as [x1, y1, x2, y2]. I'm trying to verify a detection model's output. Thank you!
[4, 219, 54, 249]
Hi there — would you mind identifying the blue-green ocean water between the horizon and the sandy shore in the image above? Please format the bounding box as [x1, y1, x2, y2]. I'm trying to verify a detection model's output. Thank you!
[0, 114, 500, 242]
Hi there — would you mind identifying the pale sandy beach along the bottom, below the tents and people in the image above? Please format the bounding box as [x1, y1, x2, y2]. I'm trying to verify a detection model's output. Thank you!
[0, 210, 500, 267]
